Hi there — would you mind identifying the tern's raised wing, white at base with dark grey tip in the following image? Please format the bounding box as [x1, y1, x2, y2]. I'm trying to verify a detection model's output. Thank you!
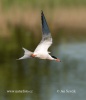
[34, 11, 52, 53]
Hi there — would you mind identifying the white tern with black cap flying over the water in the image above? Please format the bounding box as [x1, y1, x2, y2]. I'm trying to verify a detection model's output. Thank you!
[18, 11, 61, 62]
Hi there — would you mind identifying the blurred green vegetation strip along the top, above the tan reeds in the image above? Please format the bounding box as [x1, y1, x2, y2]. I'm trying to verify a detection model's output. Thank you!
[0, 0, 86, 8]
